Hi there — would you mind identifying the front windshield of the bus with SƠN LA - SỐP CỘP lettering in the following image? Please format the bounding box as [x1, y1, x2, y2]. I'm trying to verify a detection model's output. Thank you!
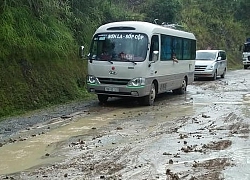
[89, 32, 148, 62]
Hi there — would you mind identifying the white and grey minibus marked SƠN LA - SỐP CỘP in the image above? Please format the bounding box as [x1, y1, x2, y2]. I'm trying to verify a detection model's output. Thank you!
[81, 21, 196, 105]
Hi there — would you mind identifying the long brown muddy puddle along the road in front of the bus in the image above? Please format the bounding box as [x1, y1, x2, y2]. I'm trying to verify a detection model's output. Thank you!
[0, 109, 126, 174]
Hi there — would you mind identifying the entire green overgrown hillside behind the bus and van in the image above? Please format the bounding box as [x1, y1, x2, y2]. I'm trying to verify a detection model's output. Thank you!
[0, 0, 250, 117]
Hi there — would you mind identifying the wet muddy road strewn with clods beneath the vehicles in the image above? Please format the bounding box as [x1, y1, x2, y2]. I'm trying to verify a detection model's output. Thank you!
[0, 70, 250, 180]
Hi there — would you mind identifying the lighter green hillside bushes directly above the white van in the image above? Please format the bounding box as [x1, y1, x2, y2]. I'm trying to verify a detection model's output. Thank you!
[179, 0, 249, 69]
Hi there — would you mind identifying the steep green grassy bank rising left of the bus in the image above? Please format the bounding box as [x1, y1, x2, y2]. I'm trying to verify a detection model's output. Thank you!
[0, 7, 87, 117]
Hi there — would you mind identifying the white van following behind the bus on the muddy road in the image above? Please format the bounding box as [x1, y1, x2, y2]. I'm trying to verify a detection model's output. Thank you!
[194, 50, 227, 80]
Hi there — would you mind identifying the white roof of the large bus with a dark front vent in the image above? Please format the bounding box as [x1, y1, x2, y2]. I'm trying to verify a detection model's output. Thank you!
[95, 21, 196, 39]
